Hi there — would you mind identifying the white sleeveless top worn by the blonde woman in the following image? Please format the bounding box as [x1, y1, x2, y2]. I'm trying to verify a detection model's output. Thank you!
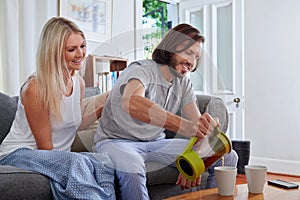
[0, 76, 82, 159]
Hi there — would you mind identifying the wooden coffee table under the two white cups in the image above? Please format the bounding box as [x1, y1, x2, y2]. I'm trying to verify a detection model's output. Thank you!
[166, 182, 300, 200]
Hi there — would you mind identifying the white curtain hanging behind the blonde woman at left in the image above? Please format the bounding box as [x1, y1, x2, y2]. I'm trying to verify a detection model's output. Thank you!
[0, 0, 57, 95]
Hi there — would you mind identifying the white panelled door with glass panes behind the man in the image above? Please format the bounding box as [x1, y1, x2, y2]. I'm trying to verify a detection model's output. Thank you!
[178, 0, 245, 140]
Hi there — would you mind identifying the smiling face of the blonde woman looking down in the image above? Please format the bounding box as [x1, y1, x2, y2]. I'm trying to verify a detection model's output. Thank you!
[65, 32, 86, 71]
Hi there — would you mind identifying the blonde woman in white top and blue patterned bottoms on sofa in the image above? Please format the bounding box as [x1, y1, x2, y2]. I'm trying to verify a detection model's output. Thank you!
[0, 17, 115, 200]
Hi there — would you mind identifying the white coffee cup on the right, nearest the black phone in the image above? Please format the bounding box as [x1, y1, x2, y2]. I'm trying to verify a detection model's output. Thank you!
[245, 165, 267, 194]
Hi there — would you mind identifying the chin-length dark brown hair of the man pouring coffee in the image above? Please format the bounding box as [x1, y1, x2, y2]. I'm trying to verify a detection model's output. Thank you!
[152, 23, 205, 71]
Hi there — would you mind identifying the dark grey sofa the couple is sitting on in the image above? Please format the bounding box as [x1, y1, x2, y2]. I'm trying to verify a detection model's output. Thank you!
[0, 88, 228, 200]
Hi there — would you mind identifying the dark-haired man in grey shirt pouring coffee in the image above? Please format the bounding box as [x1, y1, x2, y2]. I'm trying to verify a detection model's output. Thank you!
[94, 24, 237, 199]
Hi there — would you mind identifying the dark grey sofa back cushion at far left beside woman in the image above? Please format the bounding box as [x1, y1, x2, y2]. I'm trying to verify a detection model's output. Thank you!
[0, 92, 18, 143]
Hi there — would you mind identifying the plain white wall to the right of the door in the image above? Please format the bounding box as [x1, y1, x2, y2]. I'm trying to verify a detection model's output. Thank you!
[245, 0, 300, 175]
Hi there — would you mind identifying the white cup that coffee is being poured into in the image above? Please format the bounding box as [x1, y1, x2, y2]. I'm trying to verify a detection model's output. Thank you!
[214, 166, 237, 196]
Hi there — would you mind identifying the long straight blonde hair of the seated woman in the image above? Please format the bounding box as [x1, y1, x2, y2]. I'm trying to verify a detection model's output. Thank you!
[36, 17, 86, 119]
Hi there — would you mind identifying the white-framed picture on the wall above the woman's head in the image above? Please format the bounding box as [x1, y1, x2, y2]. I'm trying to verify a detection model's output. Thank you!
[58, 0, 112, 43]
